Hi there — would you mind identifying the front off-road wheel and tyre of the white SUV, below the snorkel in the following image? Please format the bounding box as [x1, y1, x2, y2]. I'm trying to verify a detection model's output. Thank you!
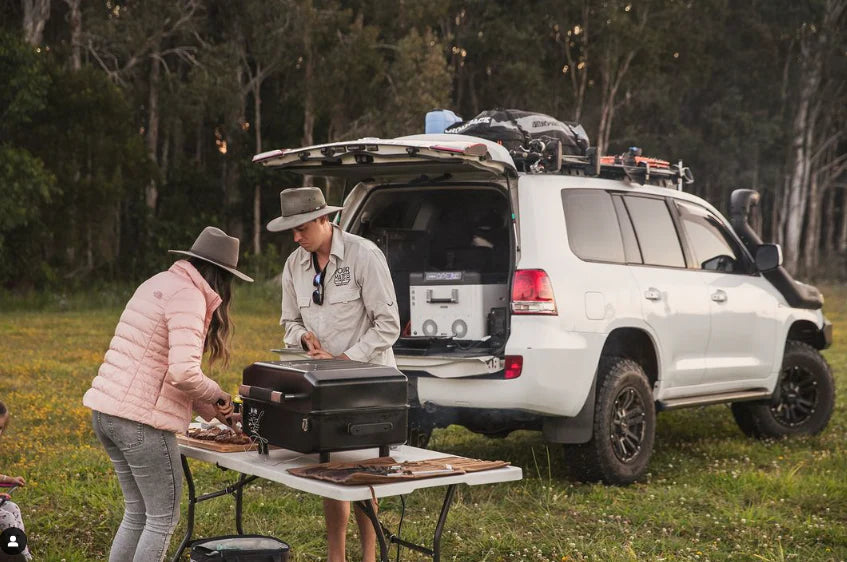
[732, 340, 835, 439]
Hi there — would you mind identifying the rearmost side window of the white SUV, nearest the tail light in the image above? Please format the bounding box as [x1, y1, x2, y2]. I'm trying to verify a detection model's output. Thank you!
[562, 189, 624, 263]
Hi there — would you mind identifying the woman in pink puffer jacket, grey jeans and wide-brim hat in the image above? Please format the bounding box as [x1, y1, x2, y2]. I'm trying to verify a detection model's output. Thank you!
[83, 227, 252, 562]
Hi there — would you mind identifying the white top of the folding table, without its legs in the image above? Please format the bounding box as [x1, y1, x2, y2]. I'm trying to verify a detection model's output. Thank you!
[179, 443, 523, 501]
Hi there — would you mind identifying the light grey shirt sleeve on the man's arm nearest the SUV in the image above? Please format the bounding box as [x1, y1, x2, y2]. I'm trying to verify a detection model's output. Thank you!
[344, 248, 400, 362]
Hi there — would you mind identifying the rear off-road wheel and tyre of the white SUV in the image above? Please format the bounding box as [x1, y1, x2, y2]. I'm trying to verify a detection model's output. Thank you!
[565, 357, 656, 485]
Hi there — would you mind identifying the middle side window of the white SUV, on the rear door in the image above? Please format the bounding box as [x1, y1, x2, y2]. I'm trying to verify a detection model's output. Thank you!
[624, 196, 685, 267]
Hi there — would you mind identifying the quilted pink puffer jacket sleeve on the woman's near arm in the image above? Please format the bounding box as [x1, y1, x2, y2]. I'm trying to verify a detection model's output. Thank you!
[165, 289, 222, 402]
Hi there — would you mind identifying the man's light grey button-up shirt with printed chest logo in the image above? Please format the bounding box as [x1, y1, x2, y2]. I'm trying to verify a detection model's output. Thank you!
[279, 225, 400, 367]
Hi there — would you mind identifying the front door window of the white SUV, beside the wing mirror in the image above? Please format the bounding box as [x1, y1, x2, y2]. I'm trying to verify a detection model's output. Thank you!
[676, 201, 747, 273]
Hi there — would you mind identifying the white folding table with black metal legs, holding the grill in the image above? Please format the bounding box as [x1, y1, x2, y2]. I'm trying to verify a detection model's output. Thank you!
[173, 443, 522, 562]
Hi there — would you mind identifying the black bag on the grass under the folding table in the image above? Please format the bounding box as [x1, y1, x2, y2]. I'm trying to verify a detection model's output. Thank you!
[191, 535, 289, 562]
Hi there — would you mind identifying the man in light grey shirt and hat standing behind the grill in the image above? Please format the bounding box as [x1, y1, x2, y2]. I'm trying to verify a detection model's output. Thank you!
[268, 187, 400, 562]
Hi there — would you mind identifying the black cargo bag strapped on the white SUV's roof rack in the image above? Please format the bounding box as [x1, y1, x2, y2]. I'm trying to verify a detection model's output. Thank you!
[444, 109, 588, 156]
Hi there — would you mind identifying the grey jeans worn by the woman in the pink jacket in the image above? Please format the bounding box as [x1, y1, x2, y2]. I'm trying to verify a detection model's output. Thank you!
[92, 411, 182, 562]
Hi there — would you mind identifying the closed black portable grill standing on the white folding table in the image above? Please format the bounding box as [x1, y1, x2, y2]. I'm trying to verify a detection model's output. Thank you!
[239, 359, 409, 461]
